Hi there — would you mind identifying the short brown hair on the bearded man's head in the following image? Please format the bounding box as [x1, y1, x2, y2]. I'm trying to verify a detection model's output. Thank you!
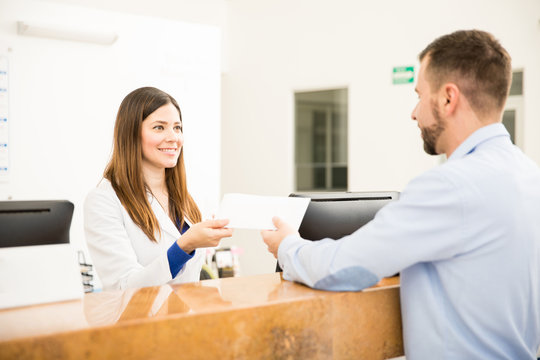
[419, 30, 512, 114]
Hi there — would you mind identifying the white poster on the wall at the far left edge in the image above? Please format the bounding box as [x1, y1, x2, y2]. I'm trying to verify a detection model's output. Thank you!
[0, 54, 9, 182]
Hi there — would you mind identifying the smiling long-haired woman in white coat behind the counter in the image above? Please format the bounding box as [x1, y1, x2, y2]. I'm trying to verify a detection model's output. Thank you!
[84, 87, 232, 290]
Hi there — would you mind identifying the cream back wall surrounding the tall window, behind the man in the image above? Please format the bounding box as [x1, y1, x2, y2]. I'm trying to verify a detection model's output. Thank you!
[222, 0, 540, 273]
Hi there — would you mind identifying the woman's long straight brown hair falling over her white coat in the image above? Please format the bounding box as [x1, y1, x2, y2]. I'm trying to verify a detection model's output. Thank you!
[103, 87, 201, 242]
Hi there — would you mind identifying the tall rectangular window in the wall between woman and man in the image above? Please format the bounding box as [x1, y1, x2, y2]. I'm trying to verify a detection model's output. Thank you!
[295, 89, 348, 191]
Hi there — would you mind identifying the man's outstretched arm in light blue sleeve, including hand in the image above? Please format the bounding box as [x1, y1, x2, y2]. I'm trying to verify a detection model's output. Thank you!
[262, 171, 464, 291]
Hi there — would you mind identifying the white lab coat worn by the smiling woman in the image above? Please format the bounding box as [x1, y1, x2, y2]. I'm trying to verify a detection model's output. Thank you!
[84, 179, 205, 290]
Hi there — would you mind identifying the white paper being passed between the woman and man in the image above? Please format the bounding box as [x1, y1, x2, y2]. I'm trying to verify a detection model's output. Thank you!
[216, 194, 310, 230]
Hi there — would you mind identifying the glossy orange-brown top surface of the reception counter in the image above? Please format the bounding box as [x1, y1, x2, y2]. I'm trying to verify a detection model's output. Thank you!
[0, 273, 399, 342]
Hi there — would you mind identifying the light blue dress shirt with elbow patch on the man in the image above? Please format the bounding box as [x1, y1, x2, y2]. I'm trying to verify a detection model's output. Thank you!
[278, 124, 540, 360]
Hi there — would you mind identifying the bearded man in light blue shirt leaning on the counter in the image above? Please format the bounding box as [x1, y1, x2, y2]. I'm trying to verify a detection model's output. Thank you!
[262, 30, 540, 360]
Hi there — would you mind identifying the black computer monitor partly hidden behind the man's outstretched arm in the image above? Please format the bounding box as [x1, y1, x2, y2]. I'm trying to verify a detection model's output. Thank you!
[276, 191, 399, 271]
